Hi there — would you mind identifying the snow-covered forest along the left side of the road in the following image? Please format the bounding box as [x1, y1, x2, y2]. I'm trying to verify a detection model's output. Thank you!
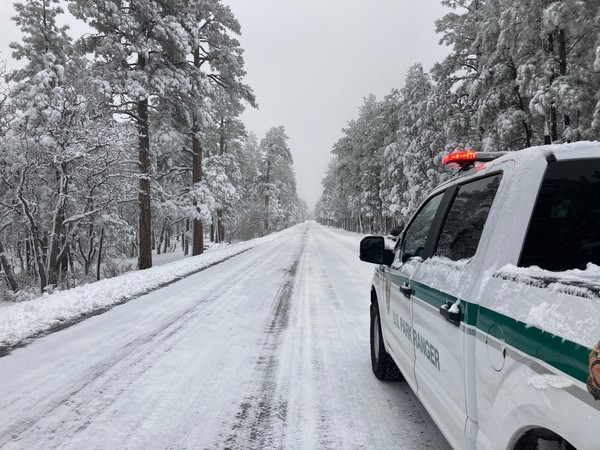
[0, 0, 306, 300]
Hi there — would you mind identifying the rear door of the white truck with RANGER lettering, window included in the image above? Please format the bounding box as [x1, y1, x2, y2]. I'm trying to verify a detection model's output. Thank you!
[410, 174, 501, 448]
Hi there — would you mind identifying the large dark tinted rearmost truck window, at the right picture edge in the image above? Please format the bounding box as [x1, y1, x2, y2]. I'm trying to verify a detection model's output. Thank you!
[519, 159, 600, 272]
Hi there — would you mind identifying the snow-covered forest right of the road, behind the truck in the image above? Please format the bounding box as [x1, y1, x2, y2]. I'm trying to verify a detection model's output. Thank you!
[316, 0, 600, 233]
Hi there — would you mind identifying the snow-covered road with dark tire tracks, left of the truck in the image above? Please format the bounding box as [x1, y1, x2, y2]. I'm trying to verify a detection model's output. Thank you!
[0, 222, 447, 449]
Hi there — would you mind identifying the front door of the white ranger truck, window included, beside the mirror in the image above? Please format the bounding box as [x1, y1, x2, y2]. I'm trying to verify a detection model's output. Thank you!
[382, 192, 444, 392]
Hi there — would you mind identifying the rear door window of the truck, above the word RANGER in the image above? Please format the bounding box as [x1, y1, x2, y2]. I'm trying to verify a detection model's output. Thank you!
[435, 174, 502, 261]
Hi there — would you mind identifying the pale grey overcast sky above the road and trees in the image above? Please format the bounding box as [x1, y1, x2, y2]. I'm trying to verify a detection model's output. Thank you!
[0, 0, 448, 209]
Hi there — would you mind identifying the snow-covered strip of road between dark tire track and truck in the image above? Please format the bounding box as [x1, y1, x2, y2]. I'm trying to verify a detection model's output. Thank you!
[280, 228, 446, 449]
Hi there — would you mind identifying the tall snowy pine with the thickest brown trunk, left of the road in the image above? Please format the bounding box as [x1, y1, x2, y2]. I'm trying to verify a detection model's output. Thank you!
[69, 0, 177, 269]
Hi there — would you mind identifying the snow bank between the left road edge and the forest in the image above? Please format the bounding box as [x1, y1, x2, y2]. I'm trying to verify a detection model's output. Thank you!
[0, 230, 288, 350]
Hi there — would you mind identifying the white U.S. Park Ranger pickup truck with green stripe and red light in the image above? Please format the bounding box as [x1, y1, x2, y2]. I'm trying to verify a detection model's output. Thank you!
[360, 142, 600, 449]
